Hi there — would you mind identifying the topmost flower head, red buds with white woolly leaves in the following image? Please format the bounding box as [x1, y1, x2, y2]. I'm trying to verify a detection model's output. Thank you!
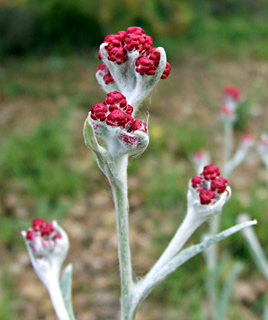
[96, 27, 170, 114]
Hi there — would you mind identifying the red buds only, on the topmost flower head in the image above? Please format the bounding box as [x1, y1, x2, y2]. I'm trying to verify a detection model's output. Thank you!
[98, 27, 170, 80]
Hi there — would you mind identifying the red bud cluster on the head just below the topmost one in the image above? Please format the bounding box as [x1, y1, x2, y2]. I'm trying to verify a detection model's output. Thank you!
[91, 91, 148, 139]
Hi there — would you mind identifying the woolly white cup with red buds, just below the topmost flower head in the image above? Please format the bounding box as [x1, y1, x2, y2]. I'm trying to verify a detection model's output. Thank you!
[84, 92, 149, 157]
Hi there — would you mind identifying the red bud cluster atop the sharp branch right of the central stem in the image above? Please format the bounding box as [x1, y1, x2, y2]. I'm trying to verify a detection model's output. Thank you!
[191, 165, 228, 204]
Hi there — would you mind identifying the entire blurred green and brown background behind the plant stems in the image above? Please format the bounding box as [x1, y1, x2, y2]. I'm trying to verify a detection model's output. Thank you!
[0, 0, 268, 320]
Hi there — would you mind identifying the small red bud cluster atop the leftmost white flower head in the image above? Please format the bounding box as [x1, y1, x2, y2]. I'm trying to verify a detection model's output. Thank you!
[26, 219, 61, 241]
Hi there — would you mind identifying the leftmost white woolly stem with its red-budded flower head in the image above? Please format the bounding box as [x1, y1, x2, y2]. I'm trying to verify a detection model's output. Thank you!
[21, 218, 74, 320]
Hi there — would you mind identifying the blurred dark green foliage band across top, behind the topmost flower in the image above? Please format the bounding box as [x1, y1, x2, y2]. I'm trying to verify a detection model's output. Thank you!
[0, 0, 268, 57]
